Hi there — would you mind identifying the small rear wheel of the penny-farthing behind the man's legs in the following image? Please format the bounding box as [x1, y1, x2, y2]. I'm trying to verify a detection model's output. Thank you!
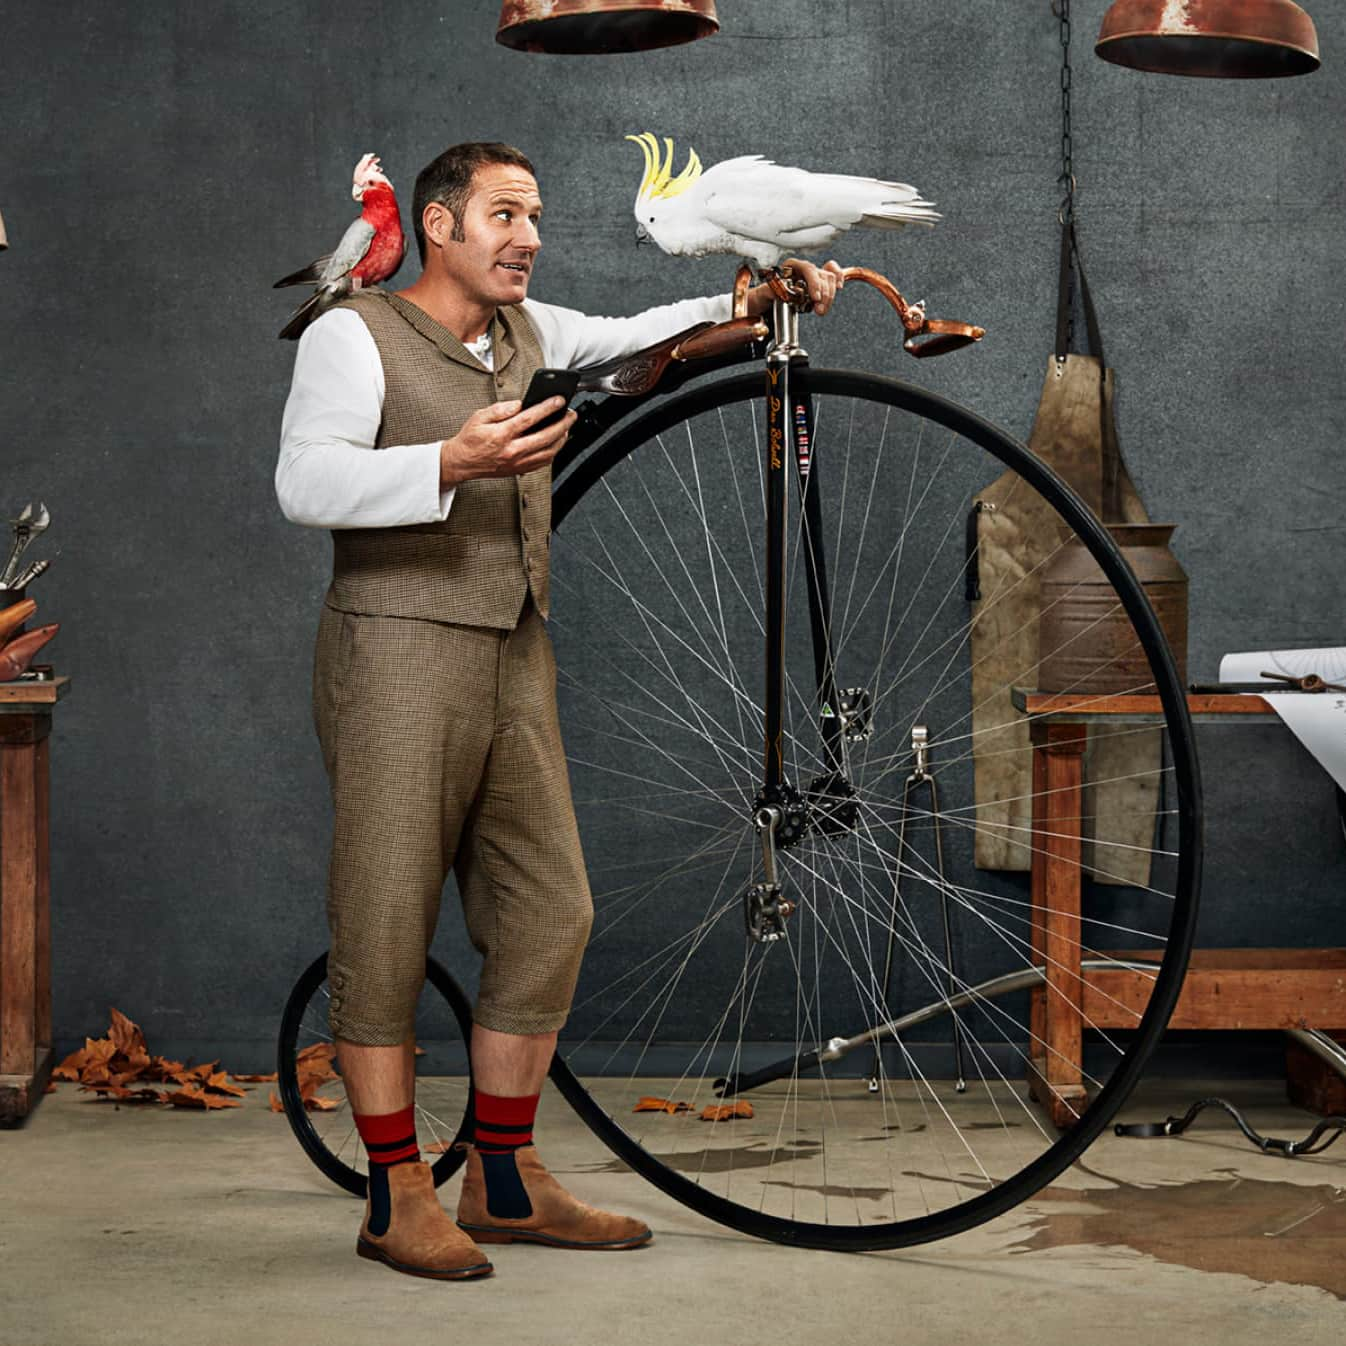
[276, 953, 472, 1197]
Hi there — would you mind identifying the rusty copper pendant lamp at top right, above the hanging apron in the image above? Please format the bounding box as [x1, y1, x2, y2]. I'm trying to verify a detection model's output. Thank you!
[1094, 0, 1320, 79]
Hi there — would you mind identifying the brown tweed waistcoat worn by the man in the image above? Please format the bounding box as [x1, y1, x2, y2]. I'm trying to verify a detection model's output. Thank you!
[327, 289, 552, 630]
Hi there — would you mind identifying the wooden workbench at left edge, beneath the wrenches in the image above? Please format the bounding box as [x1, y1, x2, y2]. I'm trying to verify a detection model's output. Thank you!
[0, 677, 70, 1124]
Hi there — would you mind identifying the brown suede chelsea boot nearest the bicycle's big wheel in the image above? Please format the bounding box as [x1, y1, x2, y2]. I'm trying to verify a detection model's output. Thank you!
[458, 1145, 654, 1252]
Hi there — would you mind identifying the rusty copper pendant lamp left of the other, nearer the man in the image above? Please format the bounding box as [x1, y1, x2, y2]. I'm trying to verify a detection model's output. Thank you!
[495, 0, 720, 55]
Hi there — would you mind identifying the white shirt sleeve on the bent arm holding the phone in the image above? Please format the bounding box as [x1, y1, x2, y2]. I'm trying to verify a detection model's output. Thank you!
[276, 310, 454, 528]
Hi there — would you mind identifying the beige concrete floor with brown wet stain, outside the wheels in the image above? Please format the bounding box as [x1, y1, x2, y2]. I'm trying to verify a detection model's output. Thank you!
[0, 1081, 1346, 1346]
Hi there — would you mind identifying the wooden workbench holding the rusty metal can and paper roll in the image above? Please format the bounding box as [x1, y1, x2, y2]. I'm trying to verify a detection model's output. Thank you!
[1014, 690, 1346, 1127]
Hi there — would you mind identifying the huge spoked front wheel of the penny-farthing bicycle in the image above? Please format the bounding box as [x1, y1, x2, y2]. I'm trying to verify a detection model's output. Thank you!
[552, 371, 1199, 1248]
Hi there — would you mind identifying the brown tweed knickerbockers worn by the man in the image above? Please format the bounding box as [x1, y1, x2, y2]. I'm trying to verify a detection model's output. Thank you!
[314, 600, 592, 1046]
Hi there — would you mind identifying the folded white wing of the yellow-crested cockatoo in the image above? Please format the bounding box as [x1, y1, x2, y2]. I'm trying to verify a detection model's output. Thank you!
[686, 155, 940, 246]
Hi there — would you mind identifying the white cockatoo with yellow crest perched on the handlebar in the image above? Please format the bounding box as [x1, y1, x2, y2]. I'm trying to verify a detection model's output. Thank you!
[626, 131, 940, 268]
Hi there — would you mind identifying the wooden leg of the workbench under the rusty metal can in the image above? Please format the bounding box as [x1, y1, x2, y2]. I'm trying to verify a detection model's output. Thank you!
[1028, 721, 1089, 1128]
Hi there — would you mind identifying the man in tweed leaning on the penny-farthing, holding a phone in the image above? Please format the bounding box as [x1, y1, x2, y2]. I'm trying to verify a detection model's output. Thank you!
[276, 144, 841, 1280]
